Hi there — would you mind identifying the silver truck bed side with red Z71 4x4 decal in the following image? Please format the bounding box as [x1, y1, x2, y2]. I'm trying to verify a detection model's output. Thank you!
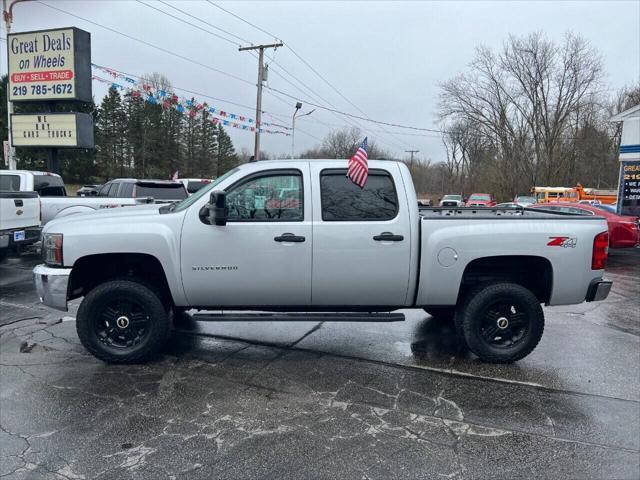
[416, 207, 607, 305]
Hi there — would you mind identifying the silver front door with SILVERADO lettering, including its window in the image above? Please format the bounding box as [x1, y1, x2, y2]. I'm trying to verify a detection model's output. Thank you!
[180, 164, 313, 307]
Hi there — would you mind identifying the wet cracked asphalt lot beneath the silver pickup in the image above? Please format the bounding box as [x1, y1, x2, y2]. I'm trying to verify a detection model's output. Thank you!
[0, 249, 640, 479]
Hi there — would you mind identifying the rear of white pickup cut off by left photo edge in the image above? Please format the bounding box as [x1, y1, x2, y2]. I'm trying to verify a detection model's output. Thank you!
[0, 191, 41, 260]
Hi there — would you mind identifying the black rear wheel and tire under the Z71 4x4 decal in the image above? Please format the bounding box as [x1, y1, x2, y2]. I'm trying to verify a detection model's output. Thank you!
[456, 283, 544, 363]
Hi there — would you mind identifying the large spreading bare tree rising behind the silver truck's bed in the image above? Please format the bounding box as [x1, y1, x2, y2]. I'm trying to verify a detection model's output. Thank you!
[440, 33, 602, 195]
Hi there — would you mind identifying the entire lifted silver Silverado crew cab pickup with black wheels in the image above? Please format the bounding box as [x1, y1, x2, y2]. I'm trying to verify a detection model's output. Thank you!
[34, 160, 611, 363]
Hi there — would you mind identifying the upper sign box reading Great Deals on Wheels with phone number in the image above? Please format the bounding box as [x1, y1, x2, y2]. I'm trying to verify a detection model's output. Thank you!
[7, 27, 92, 102]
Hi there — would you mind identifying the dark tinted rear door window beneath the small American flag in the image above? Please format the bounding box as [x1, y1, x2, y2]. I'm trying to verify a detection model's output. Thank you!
[320, 169, 398, 222]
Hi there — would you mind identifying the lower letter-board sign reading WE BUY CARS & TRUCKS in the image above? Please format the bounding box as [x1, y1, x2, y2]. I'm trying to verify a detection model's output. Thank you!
[11, 113, 94, 148]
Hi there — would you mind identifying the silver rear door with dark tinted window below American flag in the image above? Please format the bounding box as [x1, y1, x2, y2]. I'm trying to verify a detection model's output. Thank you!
[310, 162, 411, 306]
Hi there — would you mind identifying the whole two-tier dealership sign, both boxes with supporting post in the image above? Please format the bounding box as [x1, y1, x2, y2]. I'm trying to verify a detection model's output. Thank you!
[7, 27, 94, 173]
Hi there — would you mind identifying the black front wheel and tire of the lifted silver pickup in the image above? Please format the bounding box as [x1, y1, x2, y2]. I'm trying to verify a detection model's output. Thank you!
[76, 280, 171, 363]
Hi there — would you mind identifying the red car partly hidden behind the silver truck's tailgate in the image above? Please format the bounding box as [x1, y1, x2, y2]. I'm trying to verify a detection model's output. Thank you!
[529, 202, 640, 248]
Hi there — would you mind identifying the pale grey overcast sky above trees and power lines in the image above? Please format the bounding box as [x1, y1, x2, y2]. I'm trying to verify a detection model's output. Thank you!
[0, 0, 640, 161]
